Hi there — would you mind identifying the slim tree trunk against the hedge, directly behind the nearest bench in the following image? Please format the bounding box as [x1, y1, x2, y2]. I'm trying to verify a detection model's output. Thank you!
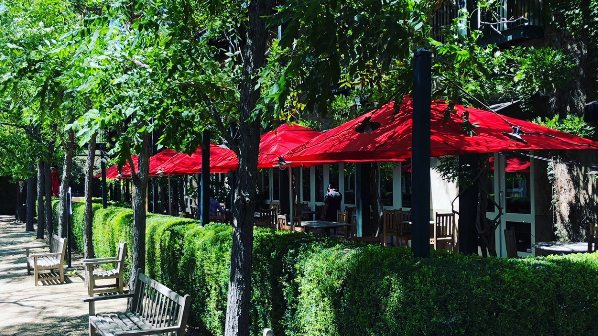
[129, 134, 150, 300]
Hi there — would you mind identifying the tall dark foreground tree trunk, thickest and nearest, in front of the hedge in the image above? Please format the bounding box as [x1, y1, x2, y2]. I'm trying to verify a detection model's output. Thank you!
[224, 0, 272, 336]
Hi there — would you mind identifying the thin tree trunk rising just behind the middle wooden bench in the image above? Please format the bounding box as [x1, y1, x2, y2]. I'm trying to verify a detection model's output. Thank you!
[83, 134, 97, 258]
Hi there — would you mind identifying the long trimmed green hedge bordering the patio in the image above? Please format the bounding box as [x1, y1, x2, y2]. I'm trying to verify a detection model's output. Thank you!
[57, 207, 598, 336]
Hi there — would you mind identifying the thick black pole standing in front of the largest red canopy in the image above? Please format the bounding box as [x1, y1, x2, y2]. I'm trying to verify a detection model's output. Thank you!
[411, 49, 432, 257]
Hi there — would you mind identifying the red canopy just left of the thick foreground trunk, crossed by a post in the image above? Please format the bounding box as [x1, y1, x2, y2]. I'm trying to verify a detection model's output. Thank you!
[156, 144, 238, 175]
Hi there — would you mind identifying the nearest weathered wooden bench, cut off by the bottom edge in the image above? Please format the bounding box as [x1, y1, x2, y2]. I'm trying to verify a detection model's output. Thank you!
[83, 270, 191, 336]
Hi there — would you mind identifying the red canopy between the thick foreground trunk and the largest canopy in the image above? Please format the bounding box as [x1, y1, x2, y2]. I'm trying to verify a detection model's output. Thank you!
[258, 124, 323, 168]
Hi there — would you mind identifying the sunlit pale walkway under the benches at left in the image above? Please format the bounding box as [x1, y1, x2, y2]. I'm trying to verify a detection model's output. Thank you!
[0, 216, 126, 336]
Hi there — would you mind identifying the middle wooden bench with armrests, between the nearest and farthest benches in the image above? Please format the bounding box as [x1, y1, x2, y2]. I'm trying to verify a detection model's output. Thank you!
[83, 243, 127, 296]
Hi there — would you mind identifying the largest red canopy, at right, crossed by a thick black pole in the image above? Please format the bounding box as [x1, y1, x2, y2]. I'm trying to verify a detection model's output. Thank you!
[285, 97, 598, 163]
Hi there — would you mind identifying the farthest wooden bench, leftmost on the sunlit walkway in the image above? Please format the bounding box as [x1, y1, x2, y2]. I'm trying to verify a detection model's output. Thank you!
[25, 235, 66, 286]
